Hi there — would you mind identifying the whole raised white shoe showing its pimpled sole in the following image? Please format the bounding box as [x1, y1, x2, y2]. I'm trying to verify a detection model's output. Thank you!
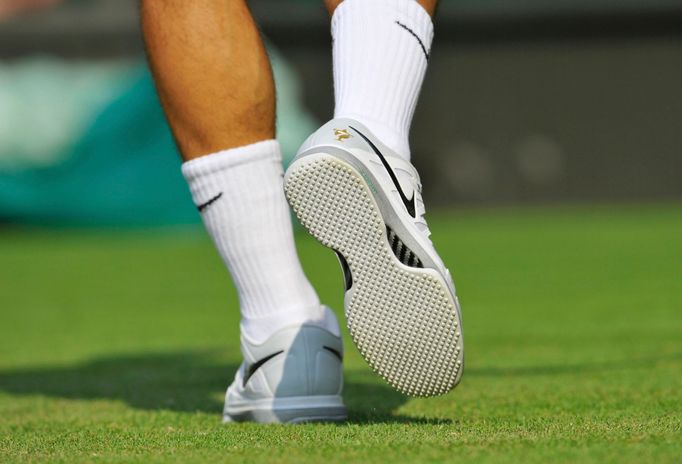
[285, 119, 464, 396]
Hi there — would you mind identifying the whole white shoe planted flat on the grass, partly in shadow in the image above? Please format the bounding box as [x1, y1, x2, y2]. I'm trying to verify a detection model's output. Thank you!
[223, 325, 347, 423]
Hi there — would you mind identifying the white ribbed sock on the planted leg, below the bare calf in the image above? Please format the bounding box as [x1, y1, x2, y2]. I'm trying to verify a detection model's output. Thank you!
[182, 140, 339, 343]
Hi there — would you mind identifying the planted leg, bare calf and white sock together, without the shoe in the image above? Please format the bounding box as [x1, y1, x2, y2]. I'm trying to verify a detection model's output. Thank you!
[141, 0, 336, 341]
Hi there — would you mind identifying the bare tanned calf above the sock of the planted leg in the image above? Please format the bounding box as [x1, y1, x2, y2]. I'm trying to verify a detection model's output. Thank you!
[142, 0, 275, 160]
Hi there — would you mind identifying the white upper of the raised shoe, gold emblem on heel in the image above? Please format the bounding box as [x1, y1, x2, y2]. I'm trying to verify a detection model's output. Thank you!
[297, 118, 455, 295]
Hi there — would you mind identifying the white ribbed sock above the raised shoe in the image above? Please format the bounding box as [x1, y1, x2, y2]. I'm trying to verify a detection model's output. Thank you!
[332, 0, 433, 160]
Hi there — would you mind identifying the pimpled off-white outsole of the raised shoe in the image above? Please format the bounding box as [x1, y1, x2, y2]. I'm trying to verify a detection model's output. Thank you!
[285, 153, 463, 396]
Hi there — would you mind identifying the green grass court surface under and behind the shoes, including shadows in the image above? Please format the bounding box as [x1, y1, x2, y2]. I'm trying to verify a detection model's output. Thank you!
[0, 204, 682, 464]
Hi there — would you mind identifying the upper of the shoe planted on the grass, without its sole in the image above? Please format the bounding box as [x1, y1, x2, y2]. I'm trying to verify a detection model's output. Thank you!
[226, 325, 343, 404]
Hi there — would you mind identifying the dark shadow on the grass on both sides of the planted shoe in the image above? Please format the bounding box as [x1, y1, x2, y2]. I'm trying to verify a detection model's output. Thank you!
[0, 352, 445, 424]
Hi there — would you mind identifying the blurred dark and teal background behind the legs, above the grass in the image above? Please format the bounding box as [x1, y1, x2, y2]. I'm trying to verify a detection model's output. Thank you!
[0, 0, 682, 225]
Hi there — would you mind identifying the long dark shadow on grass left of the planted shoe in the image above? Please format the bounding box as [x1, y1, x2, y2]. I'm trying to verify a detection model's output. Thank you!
[0, 352, 226, 412]
